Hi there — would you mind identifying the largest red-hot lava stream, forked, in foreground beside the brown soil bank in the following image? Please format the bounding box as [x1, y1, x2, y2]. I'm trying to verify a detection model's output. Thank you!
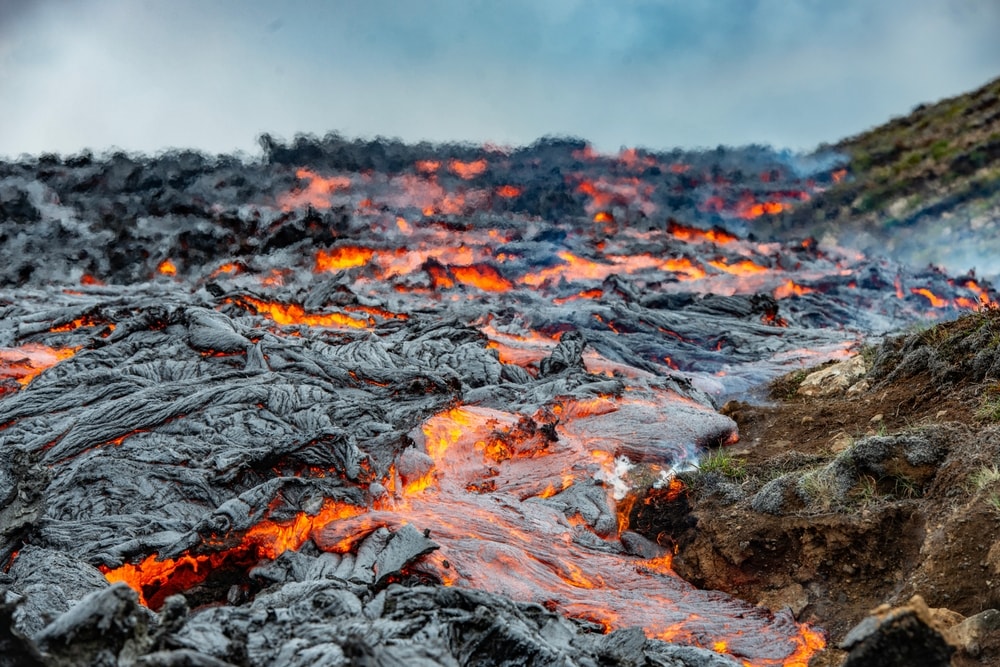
[106, 390, 824, 665]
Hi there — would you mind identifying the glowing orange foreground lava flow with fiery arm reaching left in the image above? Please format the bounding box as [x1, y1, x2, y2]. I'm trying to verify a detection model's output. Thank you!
[101, 391, 823, 666]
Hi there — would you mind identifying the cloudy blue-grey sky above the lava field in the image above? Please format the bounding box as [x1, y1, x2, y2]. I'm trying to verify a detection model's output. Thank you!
[0, 0, 1000, 157]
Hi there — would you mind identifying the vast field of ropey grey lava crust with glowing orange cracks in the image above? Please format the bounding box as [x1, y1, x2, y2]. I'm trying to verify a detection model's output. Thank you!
[0, 136, 995, 665]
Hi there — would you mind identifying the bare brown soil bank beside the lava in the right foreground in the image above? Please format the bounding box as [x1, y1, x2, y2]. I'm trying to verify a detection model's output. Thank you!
[636, 313, 1000, 665]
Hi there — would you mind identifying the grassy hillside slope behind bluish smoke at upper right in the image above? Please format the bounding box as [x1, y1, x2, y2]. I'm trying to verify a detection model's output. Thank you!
[772, 78, 1000, 276]
